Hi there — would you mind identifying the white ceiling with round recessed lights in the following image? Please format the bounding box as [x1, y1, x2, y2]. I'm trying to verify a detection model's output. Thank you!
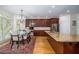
[0, 5, 79, 18]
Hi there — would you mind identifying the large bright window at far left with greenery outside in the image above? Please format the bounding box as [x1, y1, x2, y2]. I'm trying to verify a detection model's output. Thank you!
[0, 16, 10, 41]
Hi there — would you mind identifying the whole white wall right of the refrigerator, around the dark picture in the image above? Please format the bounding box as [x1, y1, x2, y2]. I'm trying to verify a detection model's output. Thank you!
[59, 14, 79, 35]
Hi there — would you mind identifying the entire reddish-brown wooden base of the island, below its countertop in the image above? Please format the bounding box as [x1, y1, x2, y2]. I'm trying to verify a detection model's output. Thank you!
[48, 36, 79, 54]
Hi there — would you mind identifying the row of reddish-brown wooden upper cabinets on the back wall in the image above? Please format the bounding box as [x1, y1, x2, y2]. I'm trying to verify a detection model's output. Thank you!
[26, 18, 59, 27]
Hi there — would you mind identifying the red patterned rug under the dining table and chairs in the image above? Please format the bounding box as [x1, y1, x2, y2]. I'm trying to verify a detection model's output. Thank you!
[0, 37, 35, 54]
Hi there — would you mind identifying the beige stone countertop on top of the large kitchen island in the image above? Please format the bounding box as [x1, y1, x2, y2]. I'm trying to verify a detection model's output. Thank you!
[45, 31, 79, 42]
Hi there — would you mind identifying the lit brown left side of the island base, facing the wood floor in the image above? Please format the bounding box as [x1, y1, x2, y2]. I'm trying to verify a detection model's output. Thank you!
[48, 37, 63, 54]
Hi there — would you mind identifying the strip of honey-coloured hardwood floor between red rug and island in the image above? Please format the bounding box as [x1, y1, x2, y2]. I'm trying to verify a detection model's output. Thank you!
[33, 36, 55, 54]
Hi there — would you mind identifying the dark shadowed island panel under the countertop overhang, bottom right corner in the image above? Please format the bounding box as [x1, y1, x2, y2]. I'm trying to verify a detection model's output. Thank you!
[64, 42, 79, 54]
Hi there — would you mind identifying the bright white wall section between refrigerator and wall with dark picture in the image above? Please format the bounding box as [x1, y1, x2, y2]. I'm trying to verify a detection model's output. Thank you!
[59, 15, 70, 35]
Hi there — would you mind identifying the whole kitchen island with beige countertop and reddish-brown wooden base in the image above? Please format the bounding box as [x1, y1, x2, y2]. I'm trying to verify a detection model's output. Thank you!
[45, 31, 79, 54]
